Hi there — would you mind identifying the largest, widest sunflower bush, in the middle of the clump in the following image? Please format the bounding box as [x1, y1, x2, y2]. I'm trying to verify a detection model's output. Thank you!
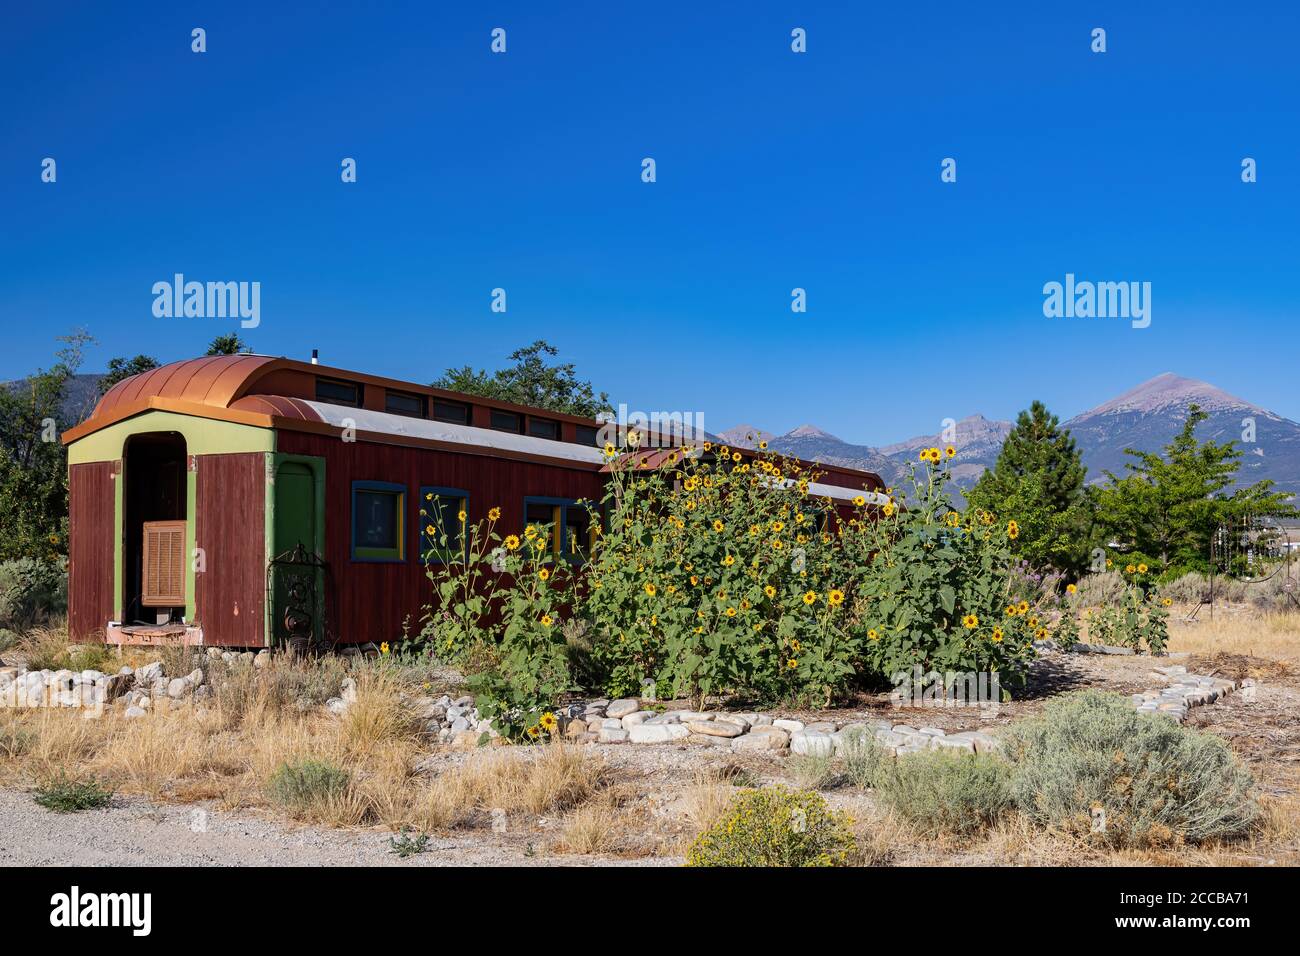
[582, 442, 859, 705]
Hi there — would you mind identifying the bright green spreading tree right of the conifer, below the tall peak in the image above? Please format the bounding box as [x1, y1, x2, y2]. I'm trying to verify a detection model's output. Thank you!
[1097, 405, 1296, 578]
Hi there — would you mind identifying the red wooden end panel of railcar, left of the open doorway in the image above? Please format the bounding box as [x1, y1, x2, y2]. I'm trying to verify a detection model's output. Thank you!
[68, 462, 117, 641]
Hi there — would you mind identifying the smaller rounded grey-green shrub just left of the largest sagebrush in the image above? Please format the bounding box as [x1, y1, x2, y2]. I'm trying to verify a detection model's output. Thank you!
[876, 750, 1011, 836]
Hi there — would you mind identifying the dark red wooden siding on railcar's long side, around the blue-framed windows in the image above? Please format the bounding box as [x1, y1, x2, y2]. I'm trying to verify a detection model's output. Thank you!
[279, 431, 605, 644]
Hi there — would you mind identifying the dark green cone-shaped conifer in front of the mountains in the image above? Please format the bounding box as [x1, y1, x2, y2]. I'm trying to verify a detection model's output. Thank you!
[966, 402, 1092, 571]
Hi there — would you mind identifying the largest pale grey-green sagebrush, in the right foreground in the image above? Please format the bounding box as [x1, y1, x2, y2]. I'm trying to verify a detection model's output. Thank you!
[1008, 691, 1258, 845]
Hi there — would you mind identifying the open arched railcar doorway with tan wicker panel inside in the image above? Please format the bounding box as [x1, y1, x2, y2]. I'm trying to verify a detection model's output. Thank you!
[122, 432, 189, 624]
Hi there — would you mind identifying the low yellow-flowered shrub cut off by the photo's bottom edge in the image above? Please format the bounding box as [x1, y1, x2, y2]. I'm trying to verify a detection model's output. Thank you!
[686, 787, 857, 866]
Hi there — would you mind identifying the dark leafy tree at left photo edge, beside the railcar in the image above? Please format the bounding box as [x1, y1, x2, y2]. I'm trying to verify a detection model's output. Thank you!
[0, 330, 94, 561]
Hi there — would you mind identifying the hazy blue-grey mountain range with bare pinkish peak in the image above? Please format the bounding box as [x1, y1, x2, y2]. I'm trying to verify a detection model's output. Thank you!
[718, 372, 1300, 492]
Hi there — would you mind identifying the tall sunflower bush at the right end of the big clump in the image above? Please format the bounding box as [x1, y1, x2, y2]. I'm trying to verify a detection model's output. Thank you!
[844, 446, 1045, 689]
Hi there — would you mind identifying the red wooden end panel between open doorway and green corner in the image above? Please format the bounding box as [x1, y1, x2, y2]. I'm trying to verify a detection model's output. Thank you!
[194, 451, 267, 648]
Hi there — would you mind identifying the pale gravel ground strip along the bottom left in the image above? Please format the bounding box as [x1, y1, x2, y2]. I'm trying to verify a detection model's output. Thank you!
[0, 790, 681, 866]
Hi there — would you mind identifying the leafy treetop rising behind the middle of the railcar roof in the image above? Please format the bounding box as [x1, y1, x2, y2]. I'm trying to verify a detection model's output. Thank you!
[433, 339, 612, 418]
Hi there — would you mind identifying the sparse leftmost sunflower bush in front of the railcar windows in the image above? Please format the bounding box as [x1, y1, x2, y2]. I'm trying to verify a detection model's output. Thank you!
[416, 497, 573, 741]
